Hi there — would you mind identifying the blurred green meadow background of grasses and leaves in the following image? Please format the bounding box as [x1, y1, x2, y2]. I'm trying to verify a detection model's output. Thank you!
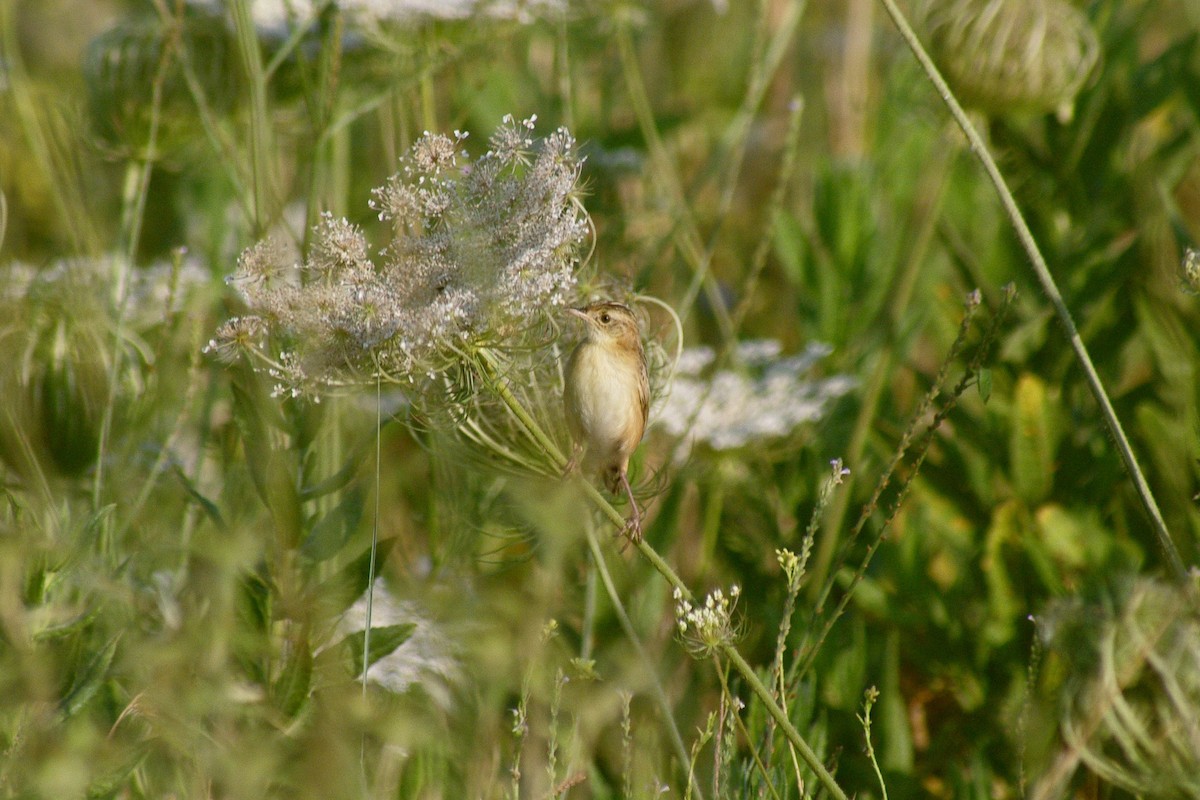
[0, 0, 1200, 799]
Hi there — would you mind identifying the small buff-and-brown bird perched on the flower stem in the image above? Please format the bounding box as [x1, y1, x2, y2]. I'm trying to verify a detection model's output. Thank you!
[563, 302, 650, 542]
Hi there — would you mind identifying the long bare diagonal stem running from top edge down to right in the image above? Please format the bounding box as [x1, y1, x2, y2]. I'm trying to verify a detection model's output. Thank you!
[881, 0, 1188, 583]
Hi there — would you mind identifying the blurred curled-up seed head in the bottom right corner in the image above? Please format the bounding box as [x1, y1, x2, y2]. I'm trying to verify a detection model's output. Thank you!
[1027, 578, 1200, 799]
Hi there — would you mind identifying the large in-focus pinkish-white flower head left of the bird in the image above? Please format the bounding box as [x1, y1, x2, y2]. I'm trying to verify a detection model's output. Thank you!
[209, 116, 589, 395]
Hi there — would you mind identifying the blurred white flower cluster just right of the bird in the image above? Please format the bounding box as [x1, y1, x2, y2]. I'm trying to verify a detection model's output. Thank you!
[653, 339, 856, 461]
